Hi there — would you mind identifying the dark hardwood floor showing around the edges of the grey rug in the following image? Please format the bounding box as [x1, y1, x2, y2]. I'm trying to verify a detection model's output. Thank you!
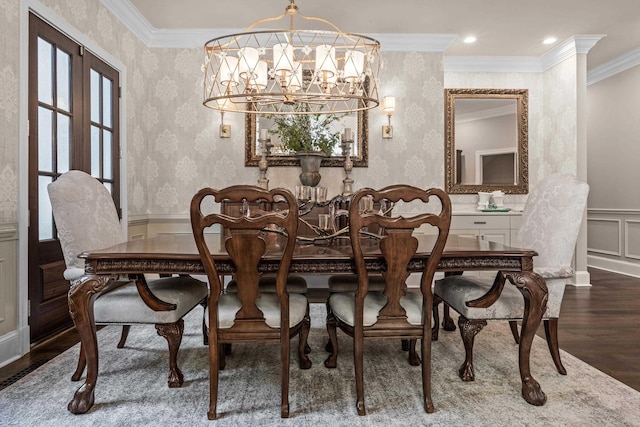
[0, 269, 640, 391]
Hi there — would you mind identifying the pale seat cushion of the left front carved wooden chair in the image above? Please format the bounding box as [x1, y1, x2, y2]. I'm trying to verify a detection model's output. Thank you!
[204, 292, 308, 329]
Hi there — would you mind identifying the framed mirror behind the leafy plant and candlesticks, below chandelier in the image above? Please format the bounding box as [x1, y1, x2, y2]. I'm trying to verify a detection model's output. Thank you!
[244, 110, 369, 167]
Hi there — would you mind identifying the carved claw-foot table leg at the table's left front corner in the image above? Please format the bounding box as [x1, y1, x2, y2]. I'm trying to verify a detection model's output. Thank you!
[67, 276, 113, 414]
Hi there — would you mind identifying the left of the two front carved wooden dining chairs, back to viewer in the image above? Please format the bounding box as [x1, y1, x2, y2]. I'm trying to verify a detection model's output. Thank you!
[190, 185, 311, 419]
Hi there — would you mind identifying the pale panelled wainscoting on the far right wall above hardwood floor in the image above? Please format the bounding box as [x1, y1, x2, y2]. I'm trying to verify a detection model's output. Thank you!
[587, 209, 640, 277]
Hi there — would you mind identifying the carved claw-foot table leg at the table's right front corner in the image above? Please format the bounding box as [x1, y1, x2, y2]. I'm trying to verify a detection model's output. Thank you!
[504, 271, 548, 406]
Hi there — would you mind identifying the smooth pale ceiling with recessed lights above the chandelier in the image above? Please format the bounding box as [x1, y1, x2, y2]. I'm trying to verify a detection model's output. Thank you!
[128, 0, 640, 69]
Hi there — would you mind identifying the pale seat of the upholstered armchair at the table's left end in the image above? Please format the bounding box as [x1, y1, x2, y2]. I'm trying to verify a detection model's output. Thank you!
[93, 277, 209, 325]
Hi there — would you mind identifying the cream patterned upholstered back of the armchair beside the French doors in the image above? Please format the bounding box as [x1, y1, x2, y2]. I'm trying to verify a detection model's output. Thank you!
[47, 170, 126, 280]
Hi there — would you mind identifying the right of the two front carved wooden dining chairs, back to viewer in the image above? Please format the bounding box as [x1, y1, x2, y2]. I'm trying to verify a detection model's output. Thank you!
[325, 185, 451, 415]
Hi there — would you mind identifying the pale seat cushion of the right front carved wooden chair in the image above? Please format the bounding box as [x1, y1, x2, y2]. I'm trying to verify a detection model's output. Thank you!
[329, 292, 422, 326]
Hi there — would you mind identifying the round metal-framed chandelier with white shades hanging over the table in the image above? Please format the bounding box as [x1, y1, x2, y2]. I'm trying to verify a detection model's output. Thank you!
[202, 0, 380, 114]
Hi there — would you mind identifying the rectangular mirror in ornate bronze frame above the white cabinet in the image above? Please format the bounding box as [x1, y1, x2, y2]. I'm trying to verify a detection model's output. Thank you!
[445, 89, 529, 194]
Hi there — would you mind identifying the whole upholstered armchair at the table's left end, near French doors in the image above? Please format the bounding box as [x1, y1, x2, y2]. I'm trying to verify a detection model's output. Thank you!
[48, 170, 208, 387]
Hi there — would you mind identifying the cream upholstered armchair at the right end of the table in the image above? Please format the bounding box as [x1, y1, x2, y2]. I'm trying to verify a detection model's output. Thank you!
[433, 174, 589, 381]
